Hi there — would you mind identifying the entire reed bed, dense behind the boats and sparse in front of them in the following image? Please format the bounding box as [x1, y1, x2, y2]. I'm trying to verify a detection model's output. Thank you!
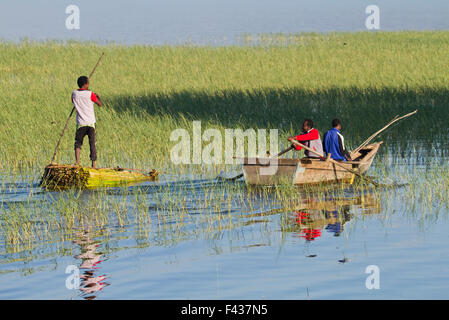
[0, 31, 449, 261]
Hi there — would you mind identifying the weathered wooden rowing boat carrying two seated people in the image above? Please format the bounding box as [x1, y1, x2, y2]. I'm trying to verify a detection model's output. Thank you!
[243, 142, 382, 185]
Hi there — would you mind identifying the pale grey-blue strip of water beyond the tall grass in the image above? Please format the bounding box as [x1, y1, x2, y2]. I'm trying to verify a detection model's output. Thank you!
[0, 0, 449, 45]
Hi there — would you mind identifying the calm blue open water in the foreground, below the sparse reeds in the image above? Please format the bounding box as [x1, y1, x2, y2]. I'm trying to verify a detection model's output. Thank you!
[0, 159, 449, 299]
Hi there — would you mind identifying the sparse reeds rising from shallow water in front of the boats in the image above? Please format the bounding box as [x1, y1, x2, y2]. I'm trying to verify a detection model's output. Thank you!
[0, 160, 449, 259]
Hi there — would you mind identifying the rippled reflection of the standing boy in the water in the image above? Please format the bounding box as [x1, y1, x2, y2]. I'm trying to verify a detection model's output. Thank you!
[73, 231, 109, 300]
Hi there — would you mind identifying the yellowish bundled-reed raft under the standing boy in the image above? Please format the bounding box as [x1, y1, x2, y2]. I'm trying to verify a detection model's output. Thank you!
[41, 164, 158, 190]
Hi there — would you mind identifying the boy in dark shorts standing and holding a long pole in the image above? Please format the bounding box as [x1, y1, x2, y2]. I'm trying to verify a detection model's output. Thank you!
[72, 76, 102, 168]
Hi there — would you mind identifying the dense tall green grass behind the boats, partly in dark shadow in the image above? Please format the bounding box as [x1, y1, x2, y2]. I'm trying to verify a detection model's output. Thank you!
[0, 31, 449, 172]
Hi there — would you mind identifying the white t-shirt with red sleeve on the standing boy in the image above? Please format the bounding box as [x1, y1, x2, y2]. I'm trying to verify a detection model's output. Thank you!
[72, 89, 98, 127]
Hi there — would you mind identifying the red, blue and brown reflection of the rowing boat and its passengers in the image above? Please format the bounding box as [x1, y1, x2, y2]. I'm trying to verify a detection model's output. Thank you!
[288, 194, 381, 242]
